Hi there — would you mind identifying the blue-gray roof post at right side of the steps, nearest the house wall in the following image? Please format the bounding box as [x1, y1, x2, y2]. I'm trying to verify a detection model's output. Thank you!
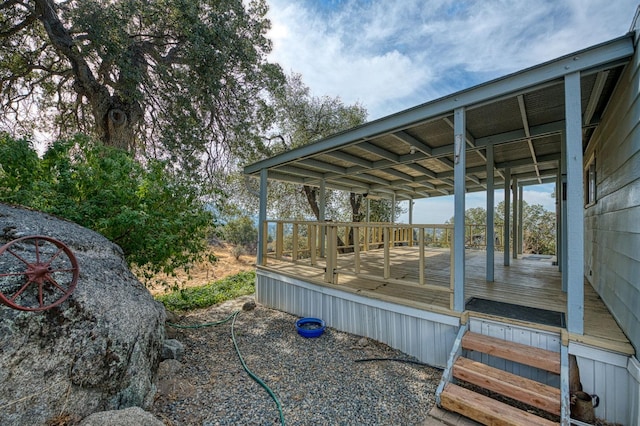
[564, 72, 584, 334]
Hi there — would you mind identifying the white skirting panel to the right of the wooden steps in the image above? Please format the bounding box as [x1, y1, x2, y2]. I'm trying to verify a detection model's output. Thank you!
[569, 342, 640, 425]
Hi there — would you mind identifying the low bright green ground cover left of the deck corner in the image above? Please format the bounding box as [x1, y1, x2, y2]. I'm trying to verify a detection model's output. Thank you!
[156, 271, 256, 311]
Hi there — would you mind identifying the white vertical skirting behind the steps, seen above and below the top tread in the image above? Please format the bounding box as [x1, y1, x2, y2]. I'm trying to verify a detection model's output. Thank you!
[465, 317, 562, 387]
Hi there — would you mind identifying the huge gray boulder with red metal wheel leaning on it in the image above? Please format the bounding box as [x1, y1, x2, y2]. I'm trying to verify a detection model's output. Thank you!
[0, 204, 165, 425]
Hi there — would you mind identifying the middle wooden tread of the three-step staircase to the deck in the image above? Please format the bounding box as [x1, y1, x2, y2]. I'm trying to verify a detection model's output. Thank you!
[453, 357, 560, 416]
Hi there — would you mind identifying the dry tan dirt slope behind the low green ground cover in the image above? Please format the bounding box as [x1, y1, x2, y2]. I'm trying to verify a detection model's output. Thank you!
[147, 243, 256, 295]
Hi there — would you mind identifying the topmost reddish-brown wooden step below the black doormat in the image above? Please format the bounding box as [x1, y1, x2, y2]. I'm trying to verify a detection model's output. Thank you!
[462, 332, 560, 374]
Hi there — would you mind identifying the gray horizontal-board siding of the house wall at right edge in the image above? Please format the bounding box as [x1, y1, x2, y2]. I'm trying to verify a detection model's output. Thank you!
[585, 31, 640, 352]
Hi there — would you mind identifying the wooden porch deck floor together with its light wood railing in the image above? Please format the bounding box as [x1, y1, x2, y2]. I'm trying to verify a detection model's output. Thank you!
[259, 221, 634, 355]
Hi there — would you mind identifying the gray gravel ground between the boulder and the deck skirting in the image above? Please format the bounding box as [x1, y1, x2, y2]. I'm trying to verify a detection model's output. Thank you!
[152, 297, 442, 426]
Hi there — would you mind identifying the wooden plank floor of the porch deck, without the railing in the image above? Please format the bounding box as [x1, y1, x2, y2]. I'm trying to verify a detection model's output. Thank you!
[261, 246, 635, 355]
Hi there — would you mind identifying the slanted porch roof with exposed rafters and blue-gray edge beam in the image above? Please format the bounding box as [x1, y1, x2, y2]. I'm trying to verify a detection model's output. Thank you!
[245, 34, 634, 200]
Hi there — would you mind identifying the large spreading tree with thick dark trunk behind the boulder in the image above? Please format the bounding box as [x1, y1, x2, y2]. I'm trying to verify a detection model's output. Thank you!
[0, 0, 284, 170]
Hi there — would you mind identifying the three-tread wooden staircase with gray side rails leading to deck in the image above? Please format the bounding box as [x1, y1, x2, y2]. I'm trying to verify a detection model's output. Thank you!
[437, 328, 568, 426]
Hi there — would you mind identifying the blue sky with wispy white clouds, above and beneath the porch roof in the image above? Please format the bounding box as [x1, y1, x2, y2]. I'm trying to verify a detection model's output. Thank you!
[267, 0, 638, 223]
